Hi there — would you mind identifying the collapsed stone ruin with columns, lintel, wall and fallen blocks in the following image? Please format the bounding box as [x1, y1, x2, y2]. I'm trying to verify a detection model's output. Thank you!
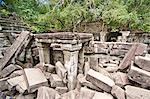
[0, 31, 150, 99]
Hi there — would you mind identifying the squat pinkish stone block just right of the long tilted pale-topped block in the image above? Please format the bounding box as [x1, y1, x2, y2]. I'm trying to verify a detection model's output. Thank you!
[112, 72, 129, 87]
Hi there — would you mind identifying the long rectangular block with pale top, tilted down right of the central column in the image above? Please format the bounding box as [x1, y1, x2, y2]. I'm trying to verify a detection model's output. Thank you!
[86, 69, 115, 92]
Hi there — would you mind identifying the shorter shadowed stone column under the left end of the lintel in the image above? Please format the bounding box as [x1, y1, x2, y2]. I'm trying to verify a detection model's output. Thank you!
[37, 43, 50, 64]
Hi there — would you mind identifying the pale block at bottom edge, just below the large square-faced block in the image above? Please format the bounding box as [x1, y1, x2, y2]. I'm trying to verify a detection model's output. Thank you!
[36, 86, 61, 99]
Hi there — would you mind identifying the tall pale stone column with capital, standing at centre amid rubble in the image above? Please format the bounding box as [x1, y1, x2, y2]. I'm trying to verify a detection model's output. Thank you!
[63, 44, 82, 90]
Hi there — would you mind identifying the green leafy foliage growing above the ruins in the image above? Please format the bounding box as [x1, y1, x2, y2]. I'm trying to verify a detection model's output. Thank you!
[2, 0, 150, 32]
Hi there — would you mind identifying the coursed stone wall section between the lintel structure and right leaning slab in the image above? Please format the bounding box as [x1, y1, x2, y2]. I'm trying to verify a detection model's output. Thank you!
[85, 41, 133, 72]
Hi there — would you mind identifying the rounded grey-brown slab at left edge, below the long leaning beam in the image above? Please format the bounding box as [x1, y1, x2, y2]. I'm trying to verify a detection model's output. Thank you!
[0, 64, 21, 78]
